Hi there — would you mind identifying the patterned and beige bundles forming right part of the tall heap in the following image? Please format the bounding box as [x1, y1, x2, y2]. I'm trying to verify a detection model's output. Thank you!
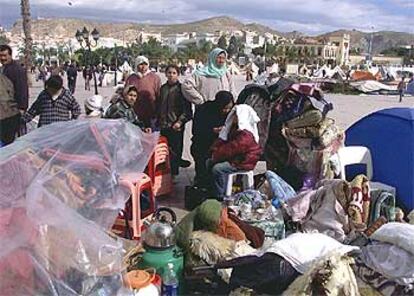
[275, 84, 344, 182]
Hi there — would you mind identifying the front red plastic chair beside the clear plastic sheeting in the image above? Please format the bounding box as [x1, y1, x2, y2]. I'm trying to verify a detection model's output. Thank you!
[112, 173, 155, 239]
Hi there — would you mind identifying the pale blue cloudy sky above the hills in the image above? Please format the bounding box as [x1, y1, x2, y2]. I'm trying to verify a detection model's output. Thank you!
[0, 0, 414, 35]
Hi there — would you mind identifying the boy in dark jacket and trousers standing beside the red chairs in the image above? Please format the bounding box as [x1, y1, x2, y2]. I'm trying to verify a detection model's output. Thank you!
[156, 65, 192, 175]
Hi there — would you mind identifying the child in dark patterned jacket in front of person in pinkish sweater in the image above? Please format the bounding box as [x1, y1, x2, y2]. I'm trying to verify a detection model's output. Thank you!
[104, 85, 151, 133]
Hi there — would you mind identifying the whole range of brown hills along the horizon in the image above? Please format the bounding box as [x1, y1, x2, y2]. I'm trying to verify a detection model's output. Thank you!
[11, 16, 414, 53]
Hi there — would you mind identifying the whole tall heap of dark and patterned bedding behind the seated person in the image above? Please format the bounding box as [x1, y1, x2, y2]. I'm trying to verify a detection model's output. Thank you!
[243, 78, 344, 189]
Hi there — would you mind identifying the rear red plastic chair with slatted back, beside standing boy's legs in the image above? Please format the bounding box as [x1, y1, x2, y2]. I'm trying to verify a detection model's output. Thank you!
[146, 136, 173, 197]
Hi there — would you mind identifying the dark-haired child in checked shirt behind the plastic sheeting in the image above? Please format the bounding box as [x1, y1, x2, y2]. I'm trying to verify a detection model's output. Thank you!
[22, 75, 81, 127]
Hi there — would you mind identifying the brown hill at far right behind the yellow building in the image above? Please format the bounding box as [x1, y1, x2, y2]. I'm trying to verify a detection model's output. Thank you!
[318, 30, 414, 54]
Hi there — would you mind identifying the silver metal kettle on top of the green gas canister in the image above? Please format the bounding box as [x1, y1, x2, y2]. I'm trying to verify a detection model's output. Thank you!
[143, 207, 177, 249]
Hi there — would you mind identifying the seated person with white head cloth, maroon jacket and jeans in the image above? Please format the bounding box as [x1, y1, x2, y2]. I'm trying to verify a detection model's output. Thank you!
[209, 104, 262, 199]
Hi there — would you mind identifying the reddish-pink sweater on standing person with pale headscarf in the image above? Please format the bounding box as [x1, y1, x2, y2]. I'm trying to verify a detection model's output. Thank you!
[125, 73, 161, 127]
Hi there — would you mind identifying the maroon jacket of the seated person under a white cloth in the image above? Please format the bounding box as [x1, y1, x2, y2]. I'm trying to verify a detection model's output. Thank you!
[211, 130, 262, 171]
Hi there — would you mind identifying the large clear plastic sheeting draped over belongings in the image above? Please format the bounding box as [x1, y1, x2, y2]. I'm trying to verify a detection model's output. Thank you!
[0, 120, 158, 296]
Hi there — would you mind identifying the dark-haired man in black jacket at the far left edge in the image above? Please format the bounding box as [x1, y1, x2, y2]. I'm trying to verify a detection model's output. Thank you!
[0, 45, 29, 144]
